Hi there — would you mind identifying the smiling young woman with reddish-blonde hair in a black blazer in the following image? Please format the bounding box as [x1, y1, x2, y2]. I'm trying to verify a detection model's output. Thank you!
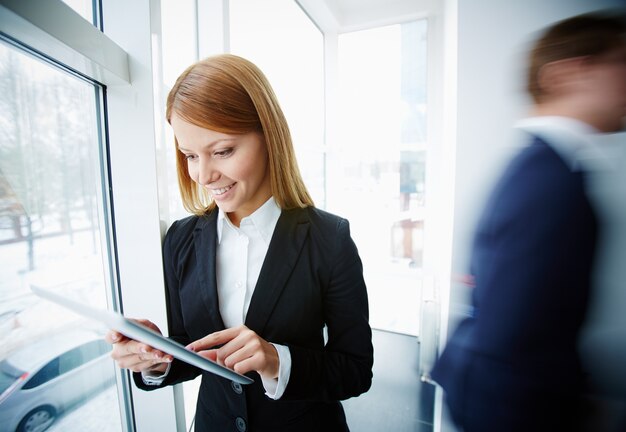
[107, 55, 373, 432]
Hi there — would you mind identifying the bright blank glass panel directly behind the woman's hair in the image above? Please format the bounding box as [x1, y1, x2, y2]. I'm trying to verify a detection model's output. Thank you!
[230, 0, 326, 207]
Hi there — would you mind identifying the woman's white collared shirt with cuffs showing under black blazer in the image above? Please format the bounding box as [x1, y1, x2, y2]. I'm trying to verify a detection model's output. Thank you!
[142, 197, 291, 399]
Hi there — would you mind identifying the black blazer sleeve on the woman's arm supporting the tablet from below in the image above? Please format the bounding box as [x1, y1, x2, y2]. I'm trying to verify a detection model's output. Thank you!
[133, 219, 200, 390]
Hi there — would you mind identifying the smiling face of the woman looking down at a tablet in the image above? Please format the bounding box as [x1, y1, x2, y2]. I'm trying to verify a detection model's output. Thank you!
[171, 114, 272, 226]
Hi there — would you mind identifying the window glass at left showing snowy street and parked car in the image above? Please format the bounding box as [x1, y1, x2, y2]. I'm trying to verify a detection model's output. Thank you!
[0, 43, 122, 431]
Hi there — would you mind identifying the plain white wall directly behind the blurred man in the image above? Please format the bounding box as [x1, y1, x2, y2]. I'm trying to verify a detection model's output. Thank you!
[435, 0, 624, 431]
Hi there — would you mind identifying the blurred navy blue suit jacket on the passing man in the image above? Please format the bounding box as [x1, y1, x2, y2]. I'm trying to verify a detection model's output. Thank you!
[432, 138, 597, 432]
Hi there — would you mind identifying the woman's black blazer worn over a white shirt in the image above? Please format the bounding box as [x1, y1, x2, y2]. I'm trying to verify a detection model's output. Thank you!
[135, 207, 373, 432]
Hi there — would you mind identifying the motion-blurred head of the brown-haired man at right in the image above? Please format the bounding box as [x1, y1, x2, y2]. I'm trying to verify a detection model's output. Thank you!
[528, 14, 626, 132]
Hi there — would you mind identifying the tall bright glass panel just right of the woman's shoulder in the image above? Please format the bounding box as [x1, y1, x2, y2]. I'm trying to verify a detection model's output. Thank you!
[328, 20, 427, 335]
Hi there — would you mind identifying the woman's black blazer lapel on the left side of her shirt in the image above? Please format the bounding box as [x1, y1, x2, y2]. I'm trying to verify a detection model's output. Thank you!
[193, 209, 224, 330]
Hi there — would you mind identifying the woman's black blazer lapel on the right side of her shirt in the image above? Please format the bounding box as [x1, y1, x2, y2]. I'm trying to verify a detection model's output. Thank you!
[245, 209, 309, 334]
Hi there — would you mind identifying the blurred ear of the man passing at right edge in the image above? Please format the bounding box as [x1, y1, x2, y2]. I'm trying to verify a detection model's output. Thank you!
[537, 57, 587, 98]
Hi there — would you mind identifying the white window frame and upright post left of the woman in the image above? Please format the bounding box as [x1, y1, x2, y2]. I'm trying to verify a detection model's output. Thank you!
[0, 0, 185, 431]
